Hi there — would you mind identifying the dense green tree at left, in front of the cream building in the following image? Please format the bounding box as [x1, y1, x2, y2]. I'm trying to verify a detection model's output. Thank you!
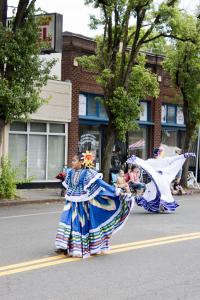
[0, 0, 55, 145]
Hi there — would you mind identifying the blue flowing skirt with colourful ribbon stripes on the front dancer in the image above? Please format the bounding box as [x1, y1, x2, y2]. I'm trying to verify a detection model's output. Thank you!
[55, 195, 133, 258]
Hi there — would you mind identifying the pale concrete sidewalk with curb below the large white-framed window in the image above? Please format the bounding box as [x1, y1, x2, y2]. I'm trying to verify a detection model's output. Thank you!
[0, 189, 65, 206]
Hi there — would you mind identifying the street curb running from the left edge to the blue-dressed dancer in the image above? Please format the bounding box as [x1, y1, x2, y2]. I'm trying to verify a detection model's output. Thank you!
[0, 198, 65, 207]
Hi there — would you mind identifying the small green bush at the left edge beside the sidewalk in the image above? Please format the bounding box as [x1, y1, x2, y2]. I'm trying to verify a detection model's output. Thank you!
[0, 157, 17, 199]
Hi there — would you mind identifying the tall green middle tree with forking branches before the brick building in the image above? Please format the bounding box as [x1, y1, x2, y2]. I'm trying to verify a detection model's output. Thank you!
[79, 0, 195, 180]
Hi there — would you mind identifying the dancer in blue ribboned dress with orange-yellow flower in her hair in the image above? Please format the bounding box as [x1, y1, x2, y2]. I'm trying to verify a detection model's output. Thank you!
[55, 152, 134, 258]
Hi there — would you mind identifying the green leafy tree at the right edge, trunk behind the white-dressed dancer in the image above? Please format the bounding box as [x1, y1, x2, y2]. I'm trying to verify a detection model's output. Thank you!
[164, 13, 200, 186]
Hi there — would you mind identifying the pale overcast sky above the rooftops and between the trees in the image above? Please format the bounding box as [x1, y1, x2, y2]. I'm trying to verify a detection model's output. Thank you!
[8, 0, 200, 37]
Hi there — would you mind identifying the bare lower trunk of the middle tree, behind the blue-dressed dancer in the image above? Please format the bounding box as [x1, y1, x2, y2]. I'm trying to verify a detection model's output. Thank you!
[102, 121, 115, 182]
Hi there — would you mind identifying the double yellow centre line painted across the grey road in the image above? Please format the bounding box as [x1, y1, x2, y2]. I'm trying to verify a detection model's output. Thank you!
[0, 232, 200, 277]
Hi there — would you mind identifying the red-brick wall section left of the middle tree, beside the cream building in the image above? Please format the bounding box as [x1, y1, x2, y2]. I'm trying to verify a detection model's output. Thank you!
[62, 35, 103, 162]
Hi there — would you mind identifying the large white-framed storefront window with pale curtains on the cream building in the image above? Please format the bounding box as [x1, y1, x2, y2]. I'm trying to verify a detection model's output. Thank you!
[9, 122, 65, 181]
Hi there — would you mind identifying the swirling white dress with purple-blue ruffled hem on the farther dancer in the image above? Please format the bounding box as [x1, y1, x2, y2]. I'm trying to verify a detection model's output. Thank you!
[126, 153, 195, 212]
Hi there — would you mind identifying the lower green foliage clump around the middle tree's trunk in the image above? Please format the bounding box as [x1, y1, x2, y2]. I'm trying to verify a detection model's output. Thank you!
[77, 54, 159, 141]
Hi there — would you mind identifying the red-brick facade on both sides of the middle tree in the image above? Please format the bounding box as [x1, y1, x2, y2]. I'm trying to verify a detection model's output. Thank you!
[62, 32, 181, 162]
